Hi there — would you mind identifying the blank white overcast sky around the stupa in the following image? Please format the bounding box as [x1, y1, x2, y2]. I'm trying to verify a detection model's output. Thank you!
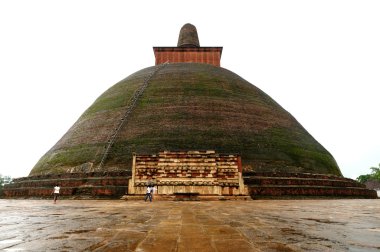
[0, 0, 380, 178]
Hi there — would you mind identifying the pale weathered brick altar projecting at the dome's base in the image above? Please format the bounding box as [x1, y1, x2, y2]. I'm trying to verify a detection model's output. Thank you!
[128, 150, 248, 195]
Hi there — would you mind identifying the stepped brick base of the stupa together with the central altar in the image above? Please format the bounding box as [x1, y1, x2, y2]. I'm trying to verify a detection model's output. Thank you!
[3, 161, 377, 199]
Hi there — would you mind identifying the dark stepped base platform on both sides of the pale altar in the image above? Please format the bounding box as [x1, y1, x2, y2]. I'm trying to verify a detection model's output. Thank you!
[4, 171, 377, 200]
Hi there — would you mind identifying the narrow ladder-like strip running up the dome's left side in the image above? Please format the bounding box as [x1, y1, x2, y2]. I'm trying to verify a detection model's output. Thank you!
[97, 61, 169, 170]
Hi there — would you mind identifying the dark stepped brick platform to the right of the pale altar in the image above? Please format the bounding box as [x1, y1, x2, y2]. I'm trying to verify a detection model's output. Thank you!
[244, 172, 377, 199]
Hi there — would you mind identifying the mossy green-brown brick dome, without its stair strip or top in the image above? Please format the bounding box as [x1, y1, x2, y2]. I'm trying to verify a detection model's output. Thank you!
[30, 63, 341, 176]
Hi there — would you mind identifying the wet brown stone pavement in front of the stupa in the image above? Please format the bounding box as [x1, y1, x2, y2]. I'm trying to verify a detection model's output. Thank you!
[0, 200, 380, 252]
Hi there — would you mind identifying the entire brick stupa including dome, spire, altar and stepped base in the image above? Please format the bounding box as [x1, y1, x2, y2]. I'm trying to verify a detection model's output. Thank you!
[3, 24, 377, 199]
